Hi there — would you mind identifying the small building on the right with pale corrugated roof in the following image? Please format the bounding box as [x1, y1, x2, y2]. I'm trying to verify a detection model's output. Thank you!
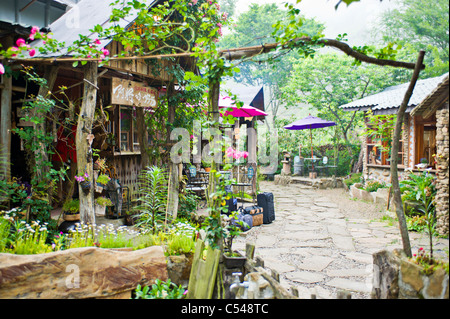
[341, 73, 448, 183]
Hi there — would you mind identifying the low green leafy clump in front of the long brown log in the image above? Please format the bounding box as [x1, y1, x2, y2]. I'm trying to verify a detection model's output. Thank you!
[135, 279, 187, 299]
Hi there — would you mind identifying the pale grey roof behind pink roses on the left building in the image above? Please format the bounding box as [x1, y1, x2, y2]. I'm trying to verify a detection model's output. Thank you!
[32, 0, 158, 57]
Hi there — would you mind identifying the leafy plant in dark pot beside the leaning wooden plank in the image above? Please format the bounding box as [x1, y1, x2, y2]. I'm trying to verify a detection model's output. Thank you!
[223, 212, 247, 268]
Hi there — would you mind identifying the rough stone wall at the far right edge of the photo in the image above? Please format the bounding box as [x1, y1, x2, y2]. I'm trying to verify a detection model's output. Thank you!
[436, 101, 450, 236]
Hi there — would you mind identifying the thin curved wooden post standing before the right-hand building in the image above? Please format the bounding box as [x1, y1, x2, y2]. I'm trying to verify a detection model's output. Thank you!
[391, 51, 425, 257]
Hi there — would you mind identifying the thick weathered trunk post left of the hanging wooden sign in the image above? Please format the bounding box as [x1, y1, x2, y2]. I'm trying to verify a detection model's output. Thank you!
[76, 62, 98, 224]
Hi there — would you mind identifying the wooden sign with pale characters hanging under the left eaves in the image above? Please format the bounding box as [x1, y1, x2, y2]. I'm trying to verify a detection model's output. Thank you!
[111, 78, 158, 107]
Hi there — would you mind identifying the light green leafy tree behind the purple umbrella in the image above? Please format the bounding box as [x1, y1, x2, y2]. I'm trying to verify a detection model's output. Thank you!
[280, 53, 402, 168]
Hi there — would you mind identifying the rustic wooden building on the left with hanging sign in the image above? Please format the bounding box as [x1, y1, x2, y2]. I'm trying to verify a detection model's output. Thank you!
[0, 0, 192, 215]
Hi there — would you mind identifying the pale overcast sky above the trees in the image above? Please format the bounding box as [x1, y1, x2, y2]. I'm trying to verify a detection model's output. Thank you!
[232, 0, 395, 45]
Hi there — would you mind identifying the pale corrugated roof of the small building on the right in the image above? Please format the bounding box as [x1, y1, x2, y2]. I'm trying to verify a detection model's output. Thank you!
[340, 73, 448, 111]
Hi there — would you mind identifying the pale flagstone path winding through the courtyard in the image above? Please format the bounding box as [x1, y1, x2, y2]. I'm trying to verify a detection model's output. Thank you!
[233, 182, 449, 299]
